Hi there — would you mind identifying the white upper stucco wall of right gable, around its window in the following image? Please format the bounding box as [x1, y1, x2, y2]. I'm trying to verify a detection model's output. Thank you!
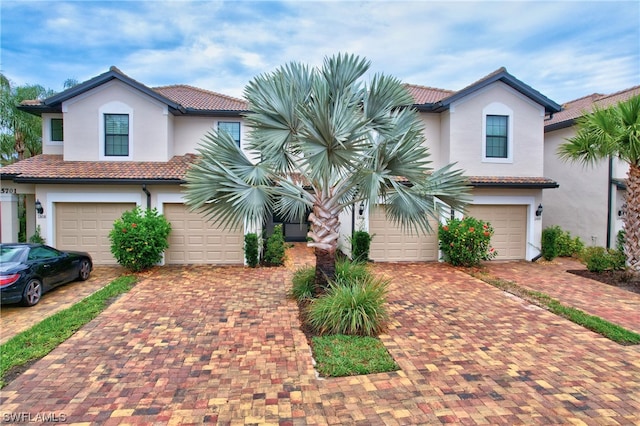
[449, 82, 544, 176]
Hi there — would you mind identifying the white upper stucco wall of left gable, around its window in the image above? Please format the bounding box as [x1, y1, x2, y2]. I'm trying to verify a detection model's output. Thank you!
[62, 80, 171, 161]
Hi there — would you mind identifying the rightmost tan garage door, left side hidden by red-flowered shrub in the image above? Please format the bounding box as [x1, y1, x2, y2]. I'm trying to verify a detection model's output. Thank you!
[469, 205, 527, 260]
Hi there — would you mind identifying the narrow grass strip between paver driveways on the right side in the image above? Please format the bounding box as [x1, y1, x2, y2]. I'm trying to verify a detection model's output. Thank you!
[471, 272, 640, 345]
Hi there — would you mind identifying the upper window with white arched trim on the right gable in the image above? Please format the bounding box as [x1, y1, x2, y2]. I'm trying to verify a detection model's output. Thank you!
[482, 102, 513, 163]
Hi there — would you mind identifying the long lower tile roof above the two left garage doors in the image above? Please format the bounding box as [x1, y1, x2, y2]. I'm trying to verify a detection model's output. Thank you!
[0, 154, 196, 182]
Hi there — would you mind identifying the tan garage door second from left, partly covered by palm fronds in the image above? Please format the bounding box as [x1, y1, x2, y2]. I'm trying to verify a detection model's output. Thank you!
[164, 203, 244, 265]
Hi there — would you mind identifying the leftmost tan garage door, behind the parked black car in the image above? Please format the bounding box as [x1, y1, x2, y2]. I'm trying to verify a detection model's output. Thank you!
[54, 203, 136, 265]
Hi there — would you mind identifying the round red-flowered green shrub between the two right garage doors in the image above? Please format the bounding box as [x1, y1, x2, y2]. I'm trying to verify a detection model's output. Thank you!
[438, 216, 498, 266]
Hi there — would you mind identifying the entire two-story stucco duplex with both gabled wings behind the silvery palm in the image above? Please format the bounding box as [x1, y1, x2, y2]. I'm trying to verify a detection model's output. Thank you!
[0, 67, 560, 264]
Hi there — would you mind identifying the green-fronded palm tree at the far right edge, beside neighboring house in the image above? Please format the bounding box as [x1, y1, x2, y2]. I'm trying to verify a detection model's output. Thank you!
[558, 96, 640, 271]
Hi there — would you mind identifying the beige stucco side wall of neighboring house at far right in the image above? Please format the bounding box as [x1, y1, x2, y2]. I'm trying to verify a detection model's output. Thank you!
[542, 128, 612, 246]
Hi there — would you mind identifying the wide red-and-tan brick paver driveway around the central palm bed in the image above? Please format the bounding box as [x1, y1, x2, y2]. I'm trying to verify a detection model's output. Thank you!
[0, 245, 640, 425]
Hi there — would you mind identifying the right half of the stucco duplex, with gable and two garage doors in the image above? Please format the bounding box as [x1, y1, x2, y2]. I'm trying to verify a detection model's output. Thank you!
[364, 68, 560, 261]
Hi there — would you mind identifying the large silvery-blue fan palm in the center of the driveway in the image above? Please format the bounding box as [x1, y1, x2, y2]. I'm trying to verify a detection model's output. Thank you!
[185, 54, 467, 294]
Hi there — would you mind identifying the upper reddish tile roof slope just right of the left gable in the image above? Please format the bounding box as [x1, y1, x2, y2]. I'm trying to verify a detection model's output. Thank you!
[153, 84, 249, 111]
